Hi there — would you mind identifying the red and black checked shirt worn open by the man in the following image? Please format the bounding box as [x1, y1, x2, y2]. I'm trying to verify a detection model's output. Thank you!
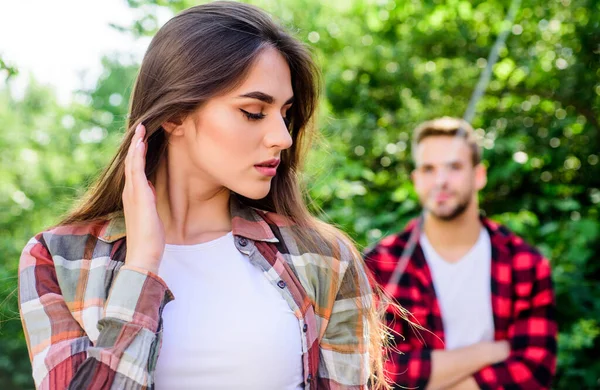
[365, 218, 557, 390]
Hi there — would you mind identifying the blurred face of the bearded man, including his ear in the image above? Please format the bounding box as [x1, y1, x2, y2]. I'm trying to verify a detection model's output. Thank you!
[412, 136, 487, 221]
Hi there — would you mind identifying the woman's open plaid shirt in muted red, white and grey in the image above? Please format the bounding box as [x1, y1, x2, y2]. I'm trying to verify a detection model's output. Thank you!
[19, 196, 373, 390]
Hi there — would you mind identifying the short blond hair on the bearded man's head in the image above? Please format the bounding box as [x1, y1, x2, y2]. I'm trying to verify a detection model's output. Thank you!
[412, 116, 481, 166]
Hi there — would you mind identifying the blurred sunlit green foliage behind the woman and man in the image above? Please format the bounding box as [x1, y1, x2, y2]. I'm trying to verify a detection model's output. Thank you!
[0, 0, 600, 390]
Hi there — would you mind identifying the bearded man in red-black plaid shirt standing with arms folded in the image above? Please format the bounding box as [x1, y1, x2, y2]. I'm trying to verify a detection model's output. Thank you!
[365, 117, 557, 390]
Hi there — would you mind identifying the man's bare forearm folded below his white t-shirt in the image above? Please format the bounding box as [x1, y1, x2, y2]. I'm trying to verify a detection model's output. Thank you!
[427, 342, 508, 390]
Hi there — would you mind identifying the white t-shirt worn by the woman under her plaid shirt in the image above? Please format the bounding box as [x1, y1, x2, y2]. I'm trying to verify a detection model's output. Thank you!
[155, 233, 303, 390]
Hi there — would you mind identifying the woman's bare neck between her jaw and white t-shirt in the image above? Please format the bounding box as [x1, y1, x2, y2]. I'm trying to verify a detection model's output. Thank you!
[154, 158, 231, 245]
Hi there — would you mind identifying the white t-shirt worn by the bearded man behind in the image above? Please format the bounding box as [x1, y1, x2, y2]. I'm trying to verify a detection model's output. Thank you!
[420, 228, 494, 349]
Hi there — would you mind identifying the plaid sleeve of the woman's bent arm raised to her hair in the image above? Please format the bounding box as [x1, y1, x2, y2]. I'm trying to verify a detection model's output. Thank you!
[19, 234, 171, 390]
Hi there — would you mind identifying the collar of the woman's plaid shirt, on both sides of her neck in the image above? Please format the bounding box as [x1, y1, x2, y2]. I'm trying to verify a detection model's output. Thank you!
[98, 194, 279, 243]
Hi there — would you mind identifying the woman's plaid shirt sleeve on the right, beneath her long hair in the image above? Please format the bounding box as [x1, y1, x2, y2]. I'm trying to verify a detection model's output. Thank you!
[317, 239, 374, 390]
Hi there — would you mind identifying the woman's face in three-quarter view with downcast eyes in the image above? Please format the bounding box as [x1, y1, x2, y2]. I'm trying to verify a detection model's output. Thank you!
[165, 48, 293, 199]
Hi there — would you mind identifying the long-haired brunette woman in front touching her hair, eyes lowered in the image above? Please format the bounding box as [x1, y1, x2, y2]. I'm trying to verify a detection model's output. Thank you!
[19, 2, 386, 389]
